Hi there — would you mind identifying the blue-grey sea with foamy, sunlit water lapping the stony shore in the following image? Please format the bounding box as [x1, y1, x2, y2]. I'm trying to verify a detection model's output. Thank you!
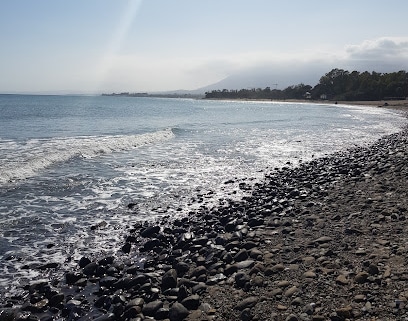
[0, 95, 406, 298]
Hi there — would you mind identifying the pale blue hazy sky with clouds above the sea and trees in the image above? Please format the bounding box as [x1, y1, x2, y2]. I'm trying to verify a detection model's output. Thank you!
[0, 0, 408, 93]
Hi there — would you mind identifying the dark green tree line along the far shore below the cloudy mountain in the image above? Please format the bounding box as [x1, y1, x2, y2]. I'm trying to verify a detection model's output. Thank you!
[205, 68, 408, 101]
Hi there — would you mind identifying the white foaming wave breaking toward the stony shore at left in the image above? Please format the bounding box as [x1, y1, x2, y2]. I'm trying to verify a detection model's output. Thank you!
[0, 129, 174, 184]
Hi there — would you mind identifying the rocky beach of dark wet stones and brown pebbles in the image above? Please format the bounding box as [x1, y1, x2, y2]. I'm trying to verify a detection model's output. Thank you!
[0, 110, 408, 321]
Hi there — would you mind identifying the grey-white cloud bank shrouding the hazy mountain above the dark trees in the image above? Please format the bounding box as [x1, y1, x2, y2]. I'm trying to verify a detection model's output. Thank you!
[204, 37, 408, 90]
